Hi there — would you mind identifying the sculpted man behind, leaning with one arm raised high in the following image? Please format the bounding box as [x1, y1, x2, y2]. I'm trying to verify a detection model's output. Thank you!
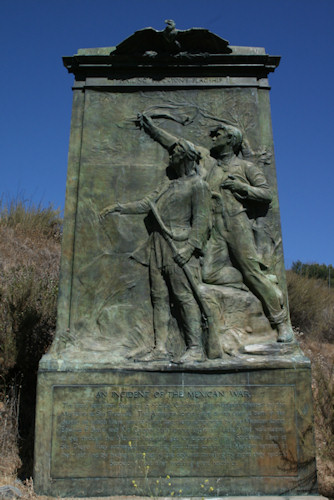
[143, 116, 294, 342]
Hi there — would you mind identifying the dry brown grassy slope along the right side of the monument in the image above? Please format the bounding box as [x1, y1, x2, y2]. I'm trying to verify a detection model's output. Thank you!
[287, 271, 334, 498]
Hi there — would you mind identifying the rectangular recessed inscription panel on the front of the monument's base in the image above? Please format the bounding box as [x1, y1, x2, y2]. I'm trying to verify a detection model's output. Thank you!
[51, 385, 297, 478]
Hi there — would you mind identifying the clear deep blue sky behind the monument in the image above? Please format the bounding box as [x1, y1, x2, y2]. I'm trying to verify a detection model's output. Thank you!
[0, 0, 334, 267]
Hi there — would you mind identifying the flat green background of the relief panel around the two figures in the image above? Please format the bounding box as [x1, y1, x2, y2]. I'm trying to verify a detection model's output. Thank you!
[52, 88, 285, 359]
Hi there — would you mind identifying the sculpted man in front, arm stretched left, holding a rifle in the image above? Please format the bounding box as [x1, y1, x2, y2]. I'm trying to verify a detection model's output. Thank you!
[100, 139, 211, 362]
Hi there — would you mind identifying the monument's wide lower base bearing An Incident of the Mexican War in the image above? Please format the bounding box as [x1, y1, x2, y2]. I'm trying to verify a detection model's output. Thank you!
[34, 356, 317, 497]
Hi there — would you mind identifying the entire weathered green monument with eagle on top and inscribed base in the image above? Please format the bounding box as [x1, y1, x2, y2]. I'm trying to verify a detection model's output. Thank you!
[34, 21, 316, 497]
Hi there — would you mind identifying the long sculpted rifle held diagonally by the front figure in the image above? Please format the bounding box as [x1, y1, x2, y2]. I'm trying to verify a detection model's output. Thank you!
[148, 200, 221, 359]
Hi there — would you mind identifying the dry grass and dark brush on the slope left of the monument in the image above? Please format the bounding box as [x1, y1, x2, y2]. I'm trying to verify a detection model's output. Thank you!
[0, 195, 61, 475]
